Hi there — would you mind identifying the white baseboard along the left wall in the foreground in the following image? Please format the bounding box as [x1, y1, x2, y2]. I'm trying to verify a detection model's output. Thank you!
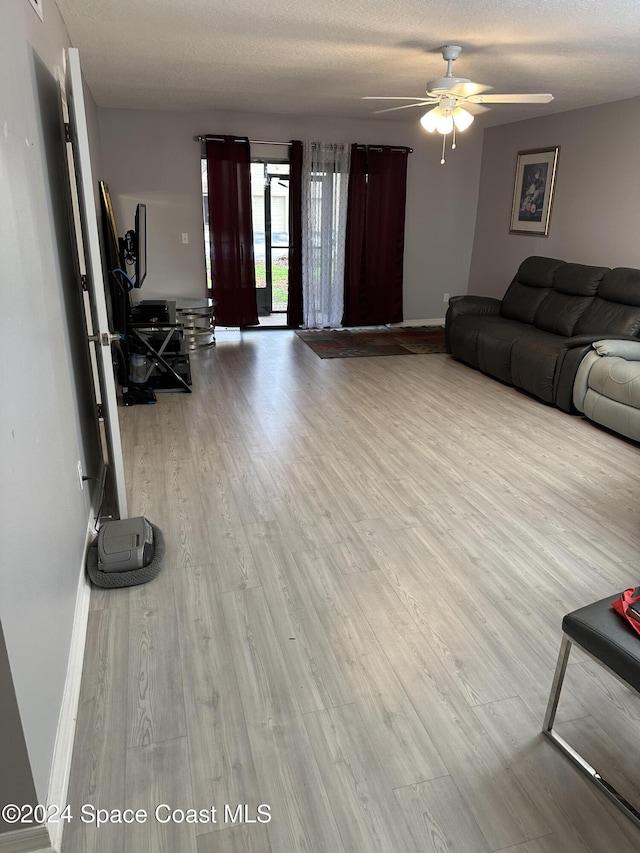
[44, 509, 95, 853]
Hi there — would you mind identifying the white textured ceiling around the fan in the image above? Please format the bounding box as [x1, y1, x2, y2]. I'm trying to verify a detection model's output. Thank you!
[56, 0, 640, 125]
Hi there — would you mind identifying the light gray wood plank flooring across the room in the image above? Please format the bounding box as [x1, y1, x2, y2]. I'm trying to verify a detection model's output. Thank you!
[63, 331, 640, 853]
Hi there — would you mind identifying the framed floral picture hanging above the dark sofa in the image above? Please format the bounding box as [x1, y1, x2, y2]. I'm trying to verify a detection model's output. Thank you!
[509, 145, 560, 237]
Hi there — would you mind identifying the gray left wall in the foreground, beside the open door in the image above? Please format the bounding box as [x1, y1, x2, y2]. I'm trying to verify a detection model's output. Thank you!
[0, 0, 99, 816]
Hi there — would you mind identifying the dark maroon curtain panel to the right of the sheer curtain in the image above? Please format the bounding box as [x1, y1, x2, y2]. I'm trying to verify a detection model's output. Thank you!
[342, 145, 409, 326]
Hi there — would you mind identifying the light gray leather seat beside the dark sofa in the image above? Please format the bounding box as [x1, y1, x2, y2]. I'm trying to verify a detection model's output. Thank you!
[573, 340, 640, 441]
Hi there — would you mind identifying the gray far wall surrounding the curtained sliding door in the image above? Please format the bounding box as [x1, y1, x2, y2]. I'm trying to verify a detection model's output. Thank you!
[98, 109, 482, 320]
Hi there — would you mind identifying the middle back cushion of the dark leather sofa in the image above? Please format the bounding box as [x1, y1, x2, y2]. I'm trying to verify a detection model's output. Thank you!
[533, 264, 609, 337]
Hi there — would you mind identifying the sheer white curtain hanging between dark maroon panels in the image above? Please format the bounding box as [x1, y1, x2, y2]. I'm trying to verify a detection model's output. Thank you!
[302, 142, 351, 329]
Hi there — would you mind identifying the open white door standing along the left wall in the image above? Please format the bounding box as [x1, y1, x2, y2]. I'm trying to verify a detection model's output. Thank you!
[62, 48, 128, 518]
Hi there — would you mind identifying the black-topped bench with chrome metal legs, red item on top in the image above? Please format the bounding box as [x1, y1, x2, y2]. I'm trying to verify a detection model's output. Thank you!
[542, 596, 640, 826]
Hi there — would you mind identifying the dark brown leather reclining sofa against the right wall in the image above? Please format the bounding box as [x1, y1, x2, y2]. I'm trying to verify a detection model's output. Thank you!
[445, 256, 640, 412]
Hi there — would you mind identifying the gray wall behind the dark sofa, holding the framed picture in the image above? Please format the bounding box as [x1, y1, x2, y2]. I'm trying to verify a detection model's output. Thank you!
[469, 98, 640, 296]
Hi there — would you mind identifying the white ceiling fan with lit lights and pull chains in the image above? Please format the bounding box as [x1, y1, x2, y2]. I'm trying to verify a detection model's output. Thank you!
[363, 44, 553, 163]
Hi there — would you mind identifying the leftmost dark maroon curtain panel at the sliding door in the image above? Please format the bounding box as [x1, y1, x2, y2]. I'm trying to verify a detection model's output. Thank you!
[206, 136, 258, 326]
